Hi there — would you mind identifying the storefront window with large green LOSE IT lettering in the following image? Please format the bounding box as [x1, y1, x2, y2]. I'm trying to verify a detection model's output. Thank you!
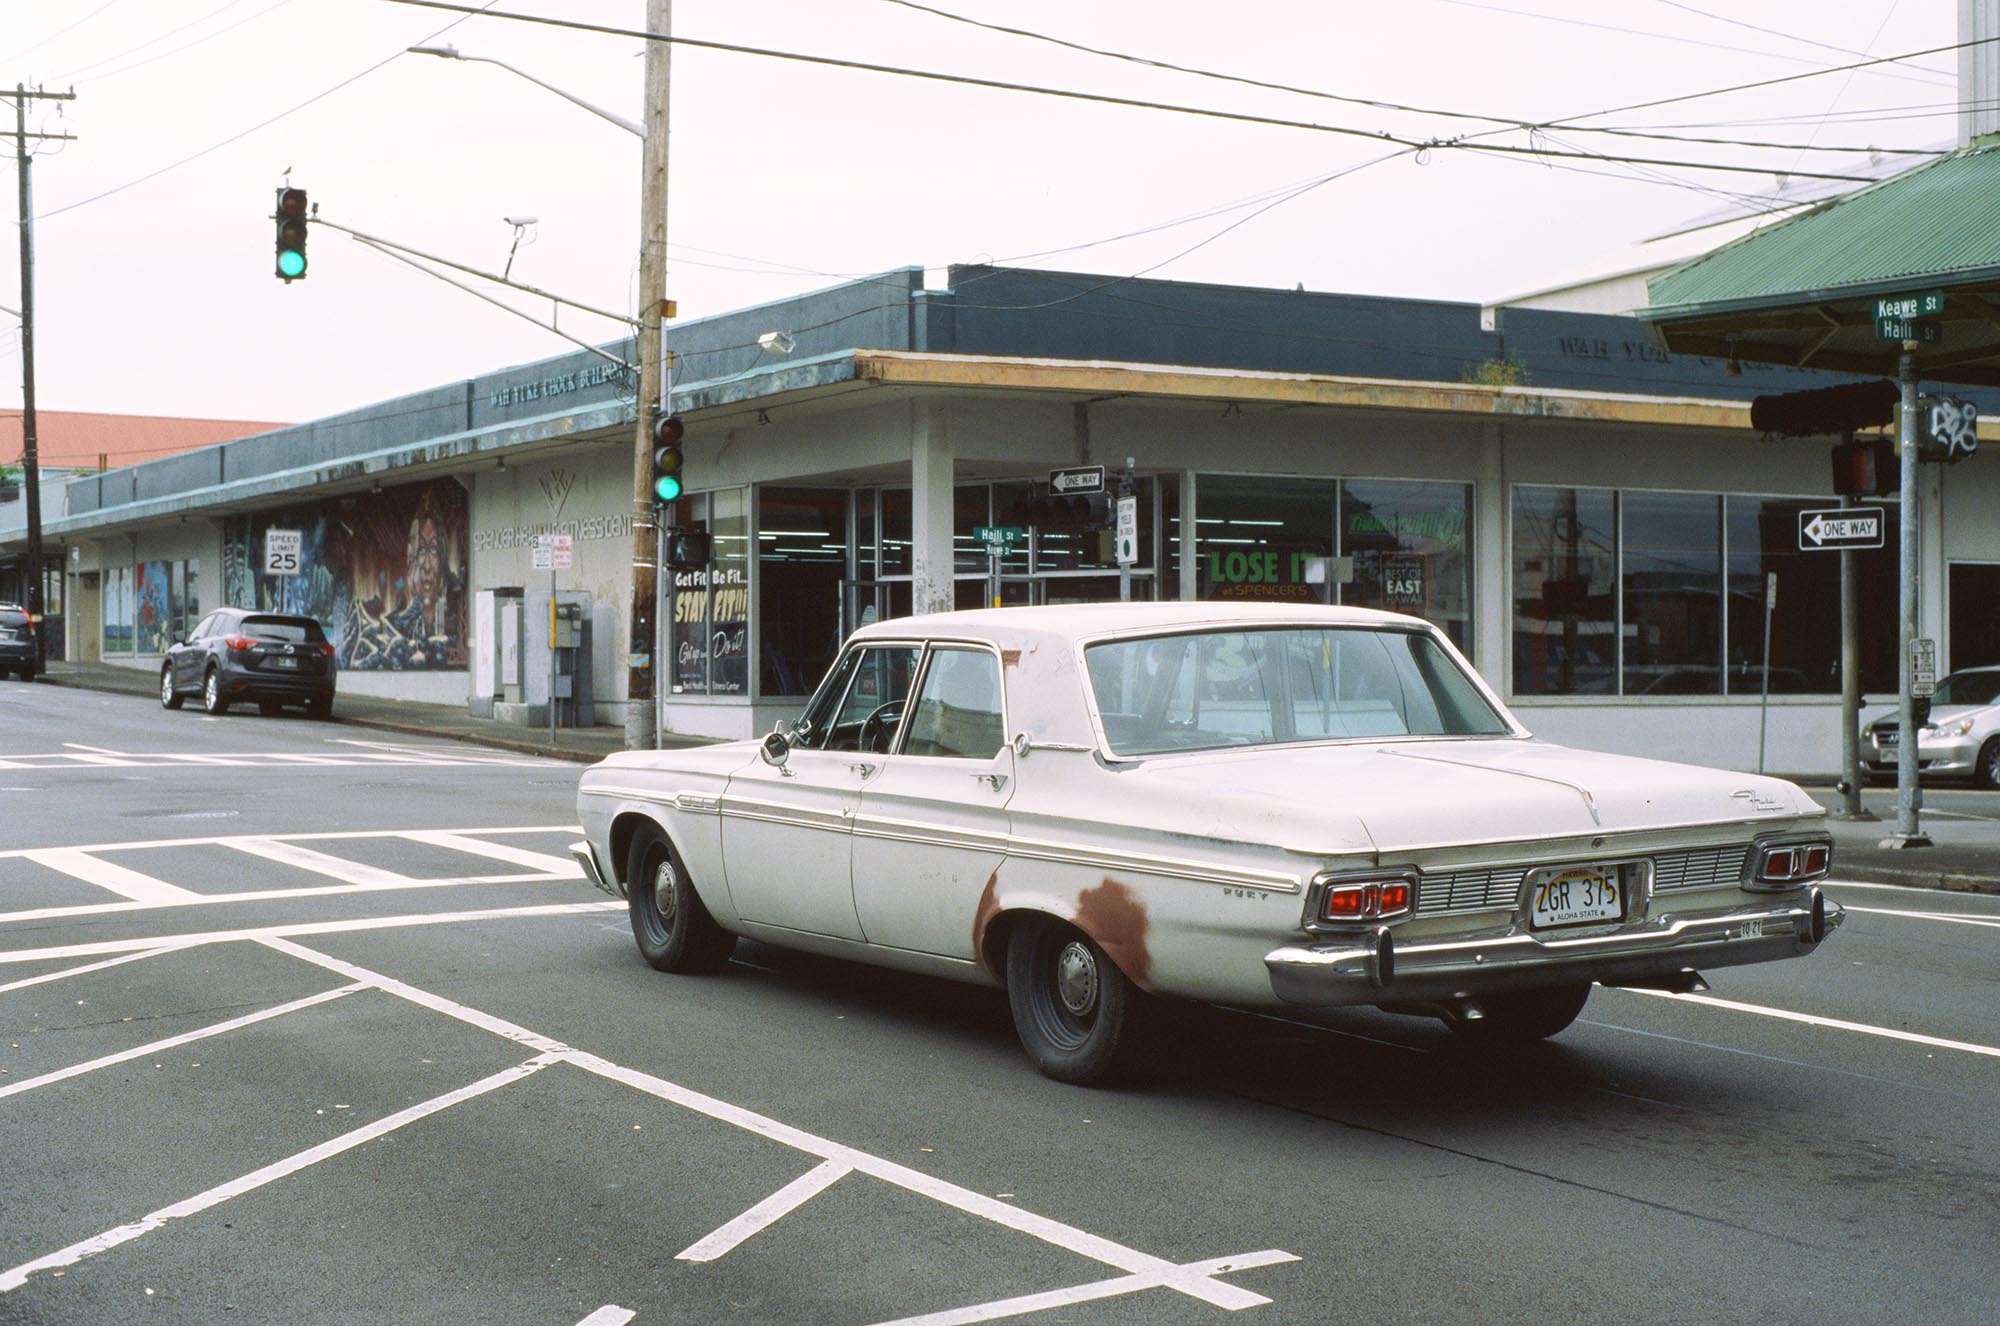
[1192, 474, 1338, 602]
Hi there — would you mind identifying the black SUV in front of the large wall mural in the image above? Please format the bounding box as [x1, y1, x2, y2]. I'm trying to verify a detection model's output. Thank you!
[160, 608, 334, 718]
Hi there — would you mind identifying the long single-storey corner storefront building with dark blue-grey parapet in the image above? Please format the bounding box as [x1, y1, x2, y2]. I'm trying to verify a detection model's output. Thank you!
[7, 268, 2000, 772]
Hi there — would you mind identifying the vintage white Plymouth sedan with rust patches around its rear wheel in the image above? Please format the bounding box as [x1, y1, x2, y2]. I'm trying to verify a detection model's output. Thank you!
[572, 604, 1840, 1082]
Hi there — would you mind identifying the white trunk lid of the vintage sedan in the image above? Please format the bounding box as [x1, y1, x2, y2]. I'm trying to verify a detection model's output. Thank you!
[1146, 738, 1824, 854]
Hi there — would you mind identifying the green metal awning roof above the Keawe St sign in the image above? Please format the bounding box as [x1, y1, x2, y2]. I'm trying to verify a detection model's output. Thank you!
[1638, 146, 2000, 386]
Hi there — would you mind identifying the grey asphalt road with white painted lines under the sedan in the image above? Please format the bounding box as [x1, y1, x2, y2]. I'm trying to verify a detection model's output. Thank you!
[0, 686, 2000, 1326]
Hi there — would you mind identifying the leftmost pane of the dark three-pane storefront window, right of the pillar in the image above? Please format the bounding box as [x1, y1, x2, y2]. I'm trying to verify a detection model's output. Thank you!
[1514, 488, 1618, 696]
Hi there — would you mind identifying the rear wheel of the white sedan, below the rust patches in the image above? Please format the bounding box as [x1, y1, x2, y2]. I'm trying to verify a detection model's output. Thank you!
[1006, 922, 1144, 1086]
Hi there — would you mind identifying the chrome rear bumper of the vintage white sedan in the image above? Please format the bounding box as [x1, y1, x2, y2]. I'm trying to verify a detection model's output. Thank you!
[1264, 888, 1842, 1004]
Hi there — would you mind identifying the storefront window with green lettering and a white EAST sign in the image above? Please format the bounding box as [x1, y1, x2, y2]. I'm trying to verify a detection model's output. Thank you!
[1340, 478, 1472, 648]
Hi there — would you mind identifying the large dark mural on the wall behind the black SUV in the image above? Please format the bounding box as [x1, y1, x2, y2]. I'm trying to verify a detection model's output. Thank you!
[222, 478, 468, 672]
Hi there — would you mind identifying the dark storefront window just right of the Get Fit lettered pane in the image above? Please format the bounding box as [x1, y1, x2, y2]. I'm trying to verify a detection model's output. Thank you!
[756, 488, 848, 696]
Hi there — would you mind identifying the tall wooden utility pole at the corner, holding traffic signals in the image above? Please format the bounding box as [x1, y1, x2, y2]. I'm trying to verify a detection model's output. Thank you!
[626, 0, 674, 750]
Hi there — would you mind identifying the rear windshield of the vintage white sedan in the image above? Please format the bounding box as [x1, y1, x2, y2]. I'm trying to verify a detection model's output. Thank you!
[1084, 628, 1508, 754]
